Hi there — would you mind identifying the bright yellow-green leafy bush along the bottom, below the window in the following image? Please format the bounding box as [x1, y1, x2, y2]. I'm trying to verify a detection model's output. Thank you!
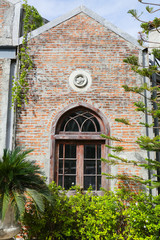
[22, 183, 160, 240]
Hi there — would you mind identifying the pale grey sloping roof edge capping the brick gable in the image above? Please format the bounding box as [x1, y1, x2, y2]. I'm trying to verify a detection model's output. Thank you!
[18, 4, 144, 50]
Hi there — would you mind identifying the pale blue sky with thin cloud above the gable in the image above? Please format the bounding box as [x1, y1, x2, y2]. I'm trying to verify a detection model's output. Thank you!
[28, 0, 159, 39]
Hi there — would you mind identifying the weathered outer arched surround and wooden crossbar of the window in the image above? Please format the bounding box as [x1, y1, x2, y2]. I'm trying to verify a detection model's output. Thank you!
[50, 103, 110, 189]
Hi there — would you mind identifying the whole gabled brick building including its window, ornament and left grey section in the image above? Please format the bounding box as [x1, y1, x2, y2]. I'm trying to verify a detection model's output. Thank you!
[0, 0, 149, 190]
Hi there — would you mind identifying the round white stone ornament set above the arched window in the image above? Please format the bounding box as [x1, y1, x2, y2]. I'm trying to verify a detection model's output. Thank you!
[69, 70, 92, 92]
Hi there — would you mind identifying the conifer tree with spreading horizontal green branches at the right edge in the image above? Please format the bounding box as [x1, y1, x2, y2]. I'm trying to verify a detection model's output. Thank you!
[102, 0, 160, 193]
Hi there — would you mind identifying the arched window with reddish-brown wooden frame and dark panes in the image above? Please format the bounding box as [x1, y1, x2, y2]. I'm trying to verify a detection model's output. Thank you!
[54, 107, 105, 191]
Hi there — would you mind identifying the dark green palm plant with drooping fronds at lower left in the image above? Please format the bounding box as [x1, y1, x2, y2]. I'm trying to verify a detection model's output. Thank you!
[0, 147, 49, 221]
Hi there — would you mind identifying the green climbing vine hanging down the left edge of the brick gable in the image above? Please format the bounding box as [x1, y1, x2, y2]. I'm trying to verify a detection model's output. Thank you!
[12, 0, 43, 108]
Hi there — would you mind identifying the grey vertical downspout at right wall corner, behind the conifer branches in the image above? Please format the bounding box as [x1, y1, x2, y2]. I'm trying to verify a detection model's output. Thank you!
[142, 49, 152, 195]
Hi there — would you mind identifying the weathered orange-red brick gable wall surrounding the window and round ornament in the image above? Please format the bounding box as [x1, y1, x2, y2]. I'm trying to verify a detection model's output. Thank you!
[16, 13, 146, 187]
